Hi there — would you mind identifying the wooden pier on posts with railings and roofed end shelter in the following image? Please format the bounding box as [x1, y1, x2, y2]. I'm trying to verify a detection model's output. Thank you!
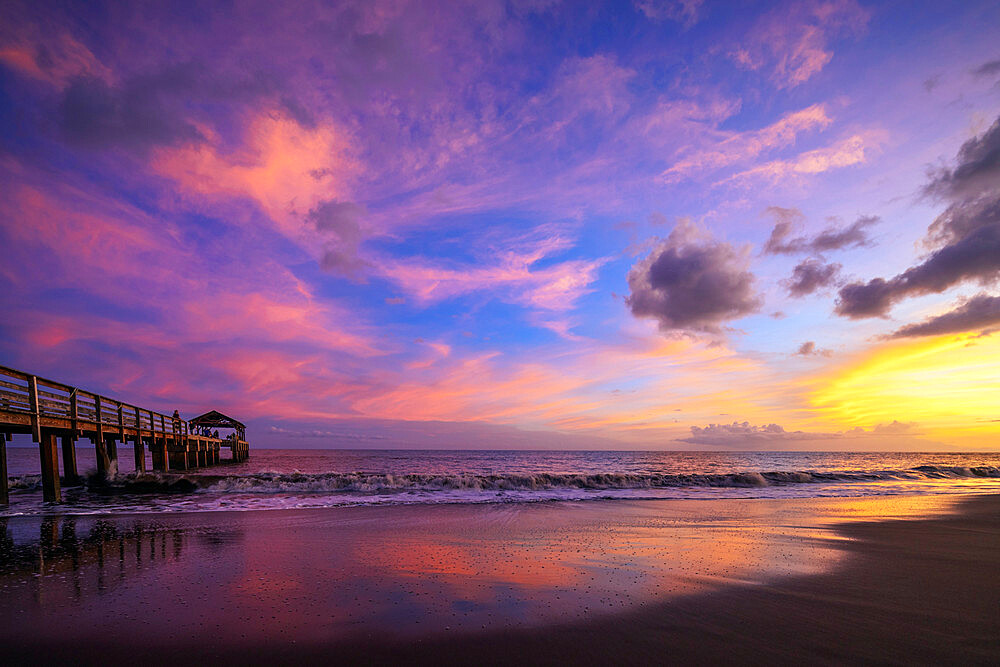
[0, 366, 250, 505]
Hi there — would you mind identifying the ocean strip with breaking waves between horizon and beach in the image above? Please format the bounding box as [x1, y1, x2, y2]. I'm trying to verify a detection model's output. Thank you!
[0, 446, 1000, 516]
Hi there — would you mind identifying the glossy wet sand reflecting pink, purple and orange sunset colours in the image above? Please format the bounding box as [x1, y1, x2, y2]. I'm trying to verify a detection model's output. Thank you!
[0, 499, 964, 650]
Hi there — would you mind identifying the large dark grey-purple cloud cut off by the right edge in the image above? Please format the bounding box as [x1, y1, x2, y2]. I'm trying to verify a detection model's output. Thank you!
[836, 120, 1000, 319]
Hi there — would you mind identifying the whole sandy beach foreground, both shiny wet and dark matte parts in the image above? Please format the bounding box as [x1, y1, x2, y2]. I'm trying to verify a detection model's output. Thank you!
[0, 496, 1000, 664]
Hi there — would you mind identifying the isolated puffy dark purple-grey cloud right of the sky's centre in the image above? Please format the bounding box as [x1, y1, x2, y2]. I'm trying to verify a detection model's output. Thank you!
[626, 221, 762, 333]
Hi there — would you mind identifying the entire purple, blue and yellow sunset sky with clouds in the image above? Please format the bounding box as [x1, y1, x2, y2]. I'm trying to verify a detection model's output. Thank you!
[0, 0, 1000, 450]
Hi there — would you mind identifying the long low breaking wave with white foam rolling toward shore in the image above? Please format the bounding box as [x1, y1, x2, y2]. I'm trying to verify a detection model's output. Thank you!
[9, 465, 1000, 495]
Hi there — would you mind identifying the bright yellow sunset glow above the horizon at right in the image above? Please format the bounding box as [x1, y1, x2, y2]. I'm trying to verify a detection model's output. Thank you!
[810, 335, 1000, 446]
